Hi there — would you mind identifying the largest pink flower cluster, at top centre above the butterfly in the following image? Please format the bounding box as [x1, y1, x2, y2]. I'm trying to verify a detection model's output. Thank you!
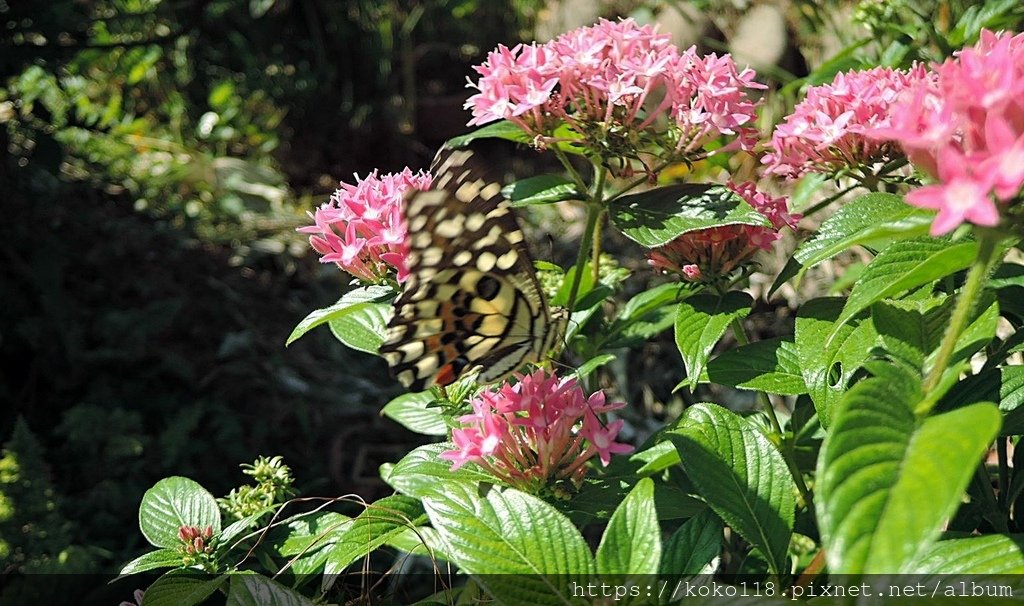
[466, 19, 765, 160]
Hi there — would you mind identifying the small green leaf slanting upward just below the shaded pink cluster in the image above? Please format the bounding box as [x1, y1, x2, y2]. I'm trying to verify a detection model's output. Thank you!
[600, 284, 689, 349]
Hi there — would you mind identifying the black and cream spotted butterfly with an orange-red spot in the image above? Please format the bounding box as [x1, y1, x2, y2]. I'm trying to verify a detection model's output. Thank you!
[380, 148, 567, 391]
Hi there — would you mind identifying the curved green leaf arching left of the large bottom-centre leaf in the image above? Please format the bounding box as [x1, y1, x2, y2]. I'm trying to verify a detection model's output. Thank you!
[324, 494, 427, 587]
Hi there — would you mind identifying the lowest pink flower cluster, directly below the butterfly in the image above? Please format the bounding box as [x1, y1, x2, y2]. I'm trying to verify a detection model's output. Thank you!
[441, 370, 633, 493]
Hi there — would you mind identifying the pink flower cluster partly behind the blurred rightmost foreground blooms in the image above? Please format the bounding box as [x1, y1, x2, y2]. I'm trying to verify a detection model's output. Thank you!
[762, 66, 927, 179]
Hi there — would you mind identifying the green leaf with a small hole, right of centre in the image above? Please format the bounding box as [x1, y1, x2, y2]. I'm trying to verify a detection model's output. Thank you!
[796, 297, 878, 429]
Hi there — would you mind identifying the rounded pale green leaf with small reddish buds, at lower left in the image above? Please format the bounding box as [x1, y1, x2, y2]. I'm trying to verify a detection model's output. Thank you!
[138, 476, 220, 548]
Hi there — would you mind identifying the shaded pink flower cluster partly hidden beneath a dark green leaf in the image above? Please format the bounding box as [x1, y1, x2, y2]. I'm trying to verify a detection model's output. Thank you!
[647, 181, 800, 284]
